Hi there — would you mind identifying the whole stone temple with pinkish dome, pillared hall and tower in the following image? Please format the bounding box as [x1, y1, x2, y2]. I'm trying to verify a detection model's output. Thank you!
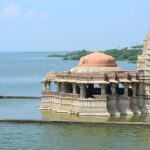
[40, 32, 150, 116]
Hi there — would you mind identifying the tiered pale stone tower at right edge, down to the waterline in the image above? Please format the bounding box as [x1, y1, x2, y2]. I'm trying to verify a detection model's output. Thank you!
[137, 30, 150, 114]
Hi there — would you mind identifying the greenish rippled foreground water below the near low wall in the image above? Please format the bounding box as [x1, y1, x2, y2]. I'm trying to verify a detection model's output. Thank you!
[0, 123, 150, 150]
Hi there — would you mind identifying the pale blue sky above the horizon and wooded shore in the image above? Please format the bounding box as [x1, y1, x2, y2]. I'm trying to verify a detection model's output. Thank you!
[0, 0, 150, 52]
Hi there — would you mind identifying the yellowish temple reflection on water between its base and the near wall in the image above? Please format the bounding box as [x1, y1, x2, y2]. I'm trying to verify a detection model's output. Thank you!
[41, 110, 150, 123]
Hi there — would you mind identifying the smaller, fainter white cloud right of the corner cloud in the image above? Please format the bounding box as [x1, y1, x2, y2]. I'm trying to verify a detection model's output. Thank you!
[26, 10, 48, 20]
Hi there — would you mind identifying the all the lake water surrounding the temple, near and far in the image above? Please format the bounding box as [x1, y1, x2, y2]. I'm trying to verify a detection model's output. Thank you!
[0, 53, 150, 150]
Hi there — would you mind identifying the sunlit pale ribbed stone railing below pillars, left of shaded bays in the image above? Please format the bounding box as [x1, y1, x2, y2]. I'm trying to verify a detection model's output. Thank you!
[41, 92, 107, 112]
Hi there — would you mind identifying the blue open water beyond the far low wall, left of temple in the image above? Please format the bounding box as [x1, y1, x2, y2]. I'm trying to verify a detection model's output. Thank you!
[0, 53, 78, 96]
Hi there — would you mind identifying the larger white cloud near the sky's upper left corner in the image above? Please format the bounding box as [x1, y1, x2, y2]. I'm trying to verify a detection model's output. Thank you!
[0, 4, 21, 19]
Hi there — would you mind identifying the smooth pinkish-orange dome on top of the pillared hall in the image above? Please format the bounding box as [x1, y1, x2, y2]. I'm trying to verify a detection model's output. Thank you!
[79, 52, 117, 67]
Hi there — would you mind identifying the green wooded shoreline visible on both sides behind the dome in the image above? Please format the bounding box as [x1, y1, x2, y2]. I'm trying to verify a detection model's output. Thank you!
[48, 45, 143, 63]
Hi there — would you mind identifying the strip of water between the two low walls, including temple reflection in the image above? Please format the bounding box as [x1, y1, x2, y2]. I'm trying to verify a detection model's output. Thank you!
[0, 99, 150, 123]
